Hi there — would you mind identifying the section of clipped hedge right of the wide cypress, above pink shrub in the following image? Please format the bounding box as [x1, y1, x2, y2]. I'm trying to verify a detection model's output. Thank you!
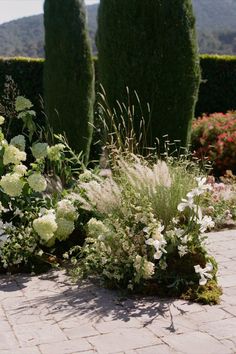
[195, 55, 236, 117]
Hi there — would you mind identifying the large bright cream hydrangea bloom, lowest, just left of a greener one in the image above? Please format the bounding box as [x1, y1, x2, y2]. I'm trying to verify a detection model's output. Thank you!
[33, 213, 57, 242]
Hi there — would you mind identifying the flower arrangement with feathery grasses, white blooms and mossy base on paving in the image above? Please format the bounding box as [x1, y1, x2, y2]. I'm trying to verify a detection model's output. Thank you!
[68, 155, 220, 303]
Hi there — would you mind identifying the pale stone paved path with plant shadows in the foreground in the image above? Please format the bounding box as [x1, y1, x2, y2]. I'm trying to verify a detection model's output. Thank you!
[0, 230, 236, 354]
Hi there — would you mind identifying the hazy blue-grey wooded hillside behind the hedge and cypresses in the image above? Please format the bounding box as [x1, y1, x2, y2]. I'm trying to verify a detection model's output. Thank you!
[0, 0, 236, 57]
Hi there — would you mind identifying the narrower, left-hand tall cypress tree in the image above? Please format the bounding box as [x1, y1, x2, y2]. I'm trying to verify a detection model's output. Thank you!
[44, 0, 94, 158]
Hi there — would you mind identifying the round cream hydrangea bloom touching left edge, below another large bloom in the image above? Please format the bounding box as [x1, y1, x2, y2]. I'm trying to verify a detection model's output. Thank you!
[0, 173, 24, 197]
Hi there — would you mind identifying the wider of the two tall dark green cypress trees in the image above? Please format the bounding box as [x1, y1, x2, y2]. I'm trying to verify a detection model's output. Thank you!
[97, 0, 200, 146]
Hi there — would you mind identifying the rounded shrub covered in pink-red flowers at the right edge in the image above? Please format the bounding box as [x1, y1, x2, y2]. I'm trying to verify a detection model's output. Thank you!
[192, 112, 236, 175]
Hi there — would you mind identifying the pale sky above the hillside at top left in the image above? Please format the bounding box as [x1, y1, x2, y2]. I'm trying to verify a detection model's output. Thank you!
[0, 0, 99, 24]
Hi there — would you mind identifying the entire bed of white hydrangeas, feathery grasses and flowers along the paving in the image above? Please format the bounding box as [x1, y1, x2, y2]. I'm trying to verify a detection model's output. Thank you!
[0, 97, 232, 303]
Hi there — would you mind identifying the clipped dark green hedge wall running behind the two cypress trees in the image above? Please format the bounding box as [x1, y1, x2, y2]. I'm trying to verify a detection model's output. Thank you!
[0, 55, 236, 117]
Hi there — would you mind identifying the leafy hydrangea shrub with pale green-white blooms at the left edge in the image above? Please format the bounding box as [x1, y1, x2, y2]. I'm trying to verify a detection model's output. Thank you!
[0, 96, 79, 272]
